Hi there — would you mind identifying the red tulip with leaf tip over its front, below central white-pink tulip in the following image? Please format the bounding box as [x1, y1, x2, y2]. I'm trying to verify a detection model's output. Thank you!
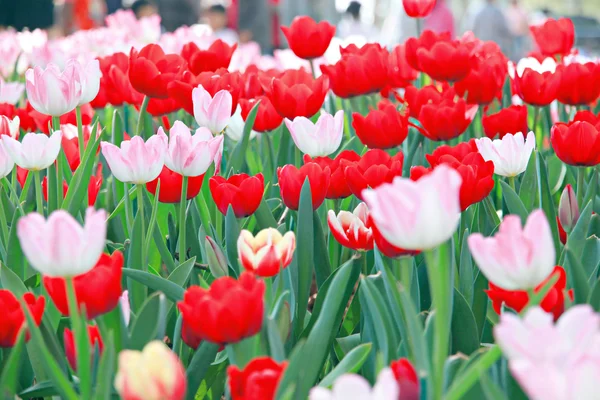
[277, 160, 331, 210]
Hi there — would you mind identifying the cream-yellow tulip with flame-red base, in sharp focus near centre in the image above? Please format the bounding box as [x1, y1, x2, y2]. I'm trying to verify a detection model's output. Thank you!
[237, 228, 296, 277]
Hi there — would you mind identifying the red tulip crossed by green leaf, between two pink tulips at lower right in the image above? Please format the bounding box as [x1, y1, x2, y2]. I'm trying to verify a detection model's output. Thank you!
[485, 266, 573, 320]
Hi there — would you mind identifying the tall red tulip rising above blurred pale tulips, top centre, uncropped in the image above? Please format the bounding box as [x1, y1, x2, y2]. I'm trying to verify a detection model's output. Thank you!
[281, 15, 335, 60]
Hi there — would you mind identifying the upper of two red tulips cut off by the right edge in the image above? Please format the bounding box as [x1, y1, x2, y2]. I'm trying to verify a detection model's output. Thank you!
[556, 62, 600, 106]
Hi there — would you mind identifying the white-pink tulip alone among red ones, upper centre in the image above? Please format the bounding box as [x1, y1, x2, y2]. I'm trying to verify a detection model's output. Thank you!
[285, 110, 344, 157]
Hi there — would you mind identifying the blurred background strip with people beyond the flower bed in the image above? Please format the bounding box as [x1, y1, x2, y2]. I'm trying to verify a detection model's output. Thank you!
[0, 0, 600, 59]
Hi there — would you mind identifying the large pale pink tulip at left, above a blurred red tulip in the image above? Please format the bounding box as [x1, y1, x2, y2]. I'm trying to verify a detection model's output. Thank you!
[17, 207, 106, 278]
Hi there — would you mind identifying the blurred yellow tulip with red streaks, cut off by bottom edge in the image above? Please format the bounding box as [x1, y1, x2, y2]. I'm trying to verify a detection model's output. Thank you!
[114, 340, 187, 400]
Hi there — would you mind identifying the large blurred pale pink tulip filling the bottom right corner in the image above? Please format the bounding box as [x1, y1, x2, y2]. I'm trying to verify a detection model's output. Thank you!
[494, 304, 600, 400]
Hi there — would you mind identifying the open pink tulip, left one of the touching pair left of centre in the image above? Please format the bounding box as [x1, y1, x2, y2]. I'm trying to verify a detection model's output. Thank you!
[100, 130, 168, 185]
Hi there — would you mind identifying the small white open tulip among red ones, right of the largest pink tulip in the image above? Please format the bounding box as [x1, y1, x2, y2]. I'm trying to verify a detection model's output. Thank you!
[475, 132, 535, 177]
